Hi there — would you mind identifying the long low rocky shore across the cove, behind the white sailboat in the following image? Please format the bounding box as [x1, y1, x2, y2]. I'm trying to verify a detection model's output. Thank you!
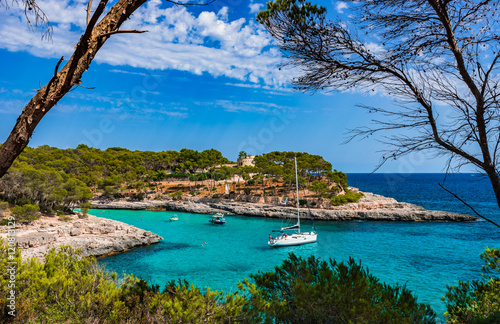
[92, 192, 478, 222]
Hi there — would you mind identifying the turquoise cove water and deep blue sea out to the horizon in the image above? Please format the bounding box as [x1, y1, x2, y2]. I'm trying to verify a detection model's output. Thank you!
[94, 173, 500, 318]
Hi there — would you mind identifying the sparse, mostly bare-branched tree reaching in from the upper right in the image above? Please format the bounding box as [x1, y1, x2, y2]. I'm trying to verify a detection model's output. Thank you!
[257, 0, 500, 210]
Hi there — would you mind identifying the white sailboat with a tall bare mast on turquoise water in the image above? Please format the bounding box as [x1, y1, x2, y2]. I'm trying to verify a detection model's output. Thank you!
[268, 158, 318, 247]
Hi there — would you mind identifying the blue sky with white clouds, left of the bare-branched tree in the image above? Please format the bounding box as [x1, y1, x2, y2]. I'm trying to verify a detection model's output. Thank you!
[0, 0, 452, 172]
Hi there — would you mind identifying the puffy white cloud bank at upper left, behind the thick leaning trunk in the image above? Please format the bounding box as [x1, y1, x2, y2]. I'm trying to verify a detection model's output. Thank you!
[0, 0, 290, 87]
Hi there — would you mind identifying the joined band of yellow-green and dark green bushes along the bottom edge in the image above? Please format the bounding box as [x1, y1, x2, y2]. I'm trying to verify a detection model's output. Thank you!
[0, 241, 435, 324]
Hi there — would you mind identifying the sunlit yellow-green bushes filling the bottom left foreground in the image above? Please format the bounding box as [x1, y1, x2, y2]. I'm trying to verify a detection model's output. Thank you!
[0, 241, 245, 324]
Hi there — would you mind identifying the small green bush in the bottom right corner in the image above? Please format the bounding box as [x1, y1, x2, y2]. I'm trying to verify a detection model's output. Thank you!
[443, 248, 500, 324]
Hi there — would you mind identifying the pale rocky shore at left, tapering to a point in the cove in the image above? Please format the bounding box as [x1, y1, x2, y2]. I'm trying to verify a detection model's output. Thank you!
[0, 215, 163, 261]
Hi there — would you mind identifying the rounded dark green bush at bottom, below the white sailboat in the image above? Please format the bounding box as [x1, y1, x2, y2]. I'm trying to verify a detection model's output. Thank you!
[239, 253, 436, 324]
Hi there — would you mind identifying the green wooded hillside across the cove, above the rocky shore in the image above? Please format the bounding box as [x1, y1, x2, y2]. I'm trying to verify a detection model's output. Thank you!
[0, 144, 359, 223]
